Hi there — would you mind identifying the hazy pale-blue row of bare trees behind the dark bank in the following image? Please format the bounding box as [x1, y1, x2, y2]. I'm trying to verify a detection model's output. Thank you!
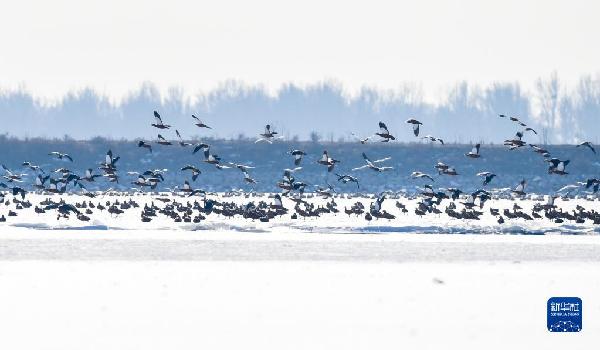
[0, 73, 600, 144]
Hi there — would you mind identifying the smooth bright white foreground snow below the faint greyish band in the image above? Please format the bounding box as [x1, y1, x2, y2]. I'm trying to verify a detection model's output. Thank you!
[0, 261, 600, 350]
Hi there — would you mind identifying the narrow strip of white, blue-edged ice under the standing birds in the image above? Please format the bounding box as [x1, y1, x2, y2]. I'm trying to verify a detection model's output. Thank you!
[0, 193, 600, 235]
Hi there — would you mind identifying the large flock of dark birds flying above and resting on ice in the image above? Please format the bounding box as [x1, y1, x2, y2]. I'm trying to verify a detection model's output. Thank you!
[0, 111, 600, 224]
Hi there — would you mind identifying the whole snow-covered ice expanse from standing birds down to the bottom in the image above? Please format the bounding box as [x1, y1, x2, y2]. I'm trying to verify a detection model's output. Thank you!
[0, 195, 600, 350]
